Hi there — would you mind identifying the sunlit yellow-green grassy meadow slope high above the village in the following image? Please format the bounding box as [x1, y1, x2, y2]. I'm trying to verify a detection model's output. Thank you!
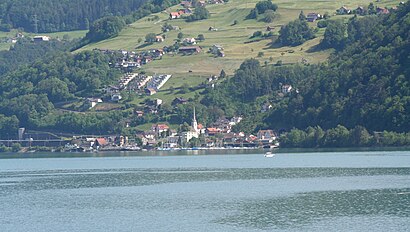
[76, 0, 400, 102]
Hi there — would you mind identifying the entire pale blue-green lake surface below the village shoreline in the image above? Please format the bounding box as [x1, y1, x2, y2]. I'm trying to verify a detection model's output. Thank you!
[0, 151, 410, 232]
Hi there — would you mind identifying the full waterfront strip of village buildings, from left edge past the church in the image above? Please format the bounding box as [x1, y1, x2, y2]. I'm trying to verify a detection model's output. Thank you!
[6, 106, 279, 152]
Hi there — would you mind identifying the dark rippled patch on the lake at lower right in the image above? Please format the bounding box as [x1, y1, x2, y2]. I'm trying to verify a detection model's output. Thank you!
[217, 189, 410, 229]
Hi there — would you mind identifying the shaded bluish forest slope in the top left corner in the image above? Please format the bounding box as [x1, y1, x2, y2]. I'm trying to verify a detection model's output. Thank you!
[0, 0, 147, 32]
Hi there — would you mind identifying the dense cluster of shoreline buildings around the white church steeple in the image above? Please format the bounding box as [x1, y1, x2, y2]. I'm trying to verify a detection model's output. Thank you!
[133, 109, 278, 150]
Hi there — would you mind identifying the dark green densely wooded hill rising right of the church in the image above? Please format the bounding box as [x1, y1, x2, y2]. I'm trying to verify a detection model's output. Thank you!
[202, 2, 410, 132]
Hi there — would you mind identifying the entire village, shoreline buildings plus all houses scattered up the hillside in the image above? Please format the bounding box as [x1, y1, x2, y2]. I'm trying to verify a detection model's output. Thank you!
[0, 0, 404, 151]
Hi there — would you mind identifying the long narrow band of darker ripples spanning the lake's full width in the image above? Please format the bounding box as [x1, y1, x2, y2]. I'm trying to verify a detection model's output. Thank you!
[0, 168, 410, 194]
